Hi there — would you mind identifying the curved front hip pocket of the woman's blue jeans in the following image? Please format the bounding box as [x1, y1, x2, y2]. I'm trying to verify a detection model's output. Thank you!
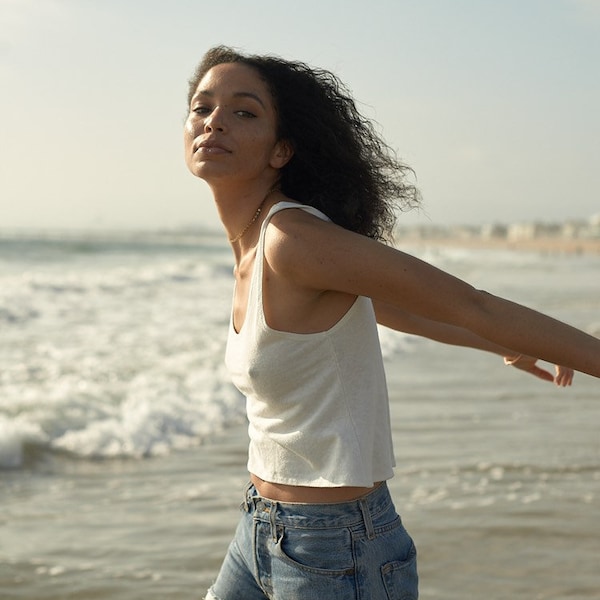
[275, 528, 354, 577]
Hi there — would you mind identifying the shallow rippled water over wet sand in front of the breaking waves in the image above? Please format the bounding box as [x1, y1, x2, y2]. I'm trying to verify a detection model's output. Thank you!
[0, 344, 600, 600]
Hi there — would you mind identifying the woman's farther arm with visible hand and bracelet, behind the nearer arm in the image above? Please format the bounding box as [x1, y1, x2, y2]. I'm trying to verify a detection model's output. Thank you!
[373, 300, 573, 387]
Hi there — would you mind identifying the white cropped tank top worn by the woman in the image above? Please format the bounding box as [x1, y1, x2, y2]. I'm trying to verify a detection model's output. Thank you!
[225, 202, 395, 487]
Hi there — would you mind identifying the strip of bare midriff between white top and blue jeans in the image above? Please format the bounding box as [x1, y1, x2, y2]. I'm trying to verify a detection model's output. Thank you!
[250, 475, 383, 504]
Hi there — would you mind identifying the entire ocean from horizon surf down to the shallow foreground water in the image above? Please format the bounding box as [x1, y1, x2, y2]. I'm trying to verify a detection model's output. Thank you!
[0, 231, 600, 600]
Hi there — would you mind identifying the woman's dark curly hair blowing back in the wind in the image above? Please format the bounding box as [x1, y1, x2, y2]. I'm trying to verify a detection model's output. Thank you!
[188, 46, 419, 240]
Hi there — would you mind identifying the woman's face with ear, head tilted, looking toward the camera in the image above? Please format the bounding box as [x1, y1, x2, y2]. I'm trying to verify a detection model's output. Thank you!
[184, 63, 291, 183]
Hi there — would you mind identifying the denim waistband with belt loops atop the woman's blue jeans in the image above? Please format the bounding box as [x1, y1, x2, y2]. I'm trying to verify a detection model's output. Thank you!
[242, 482, 395, 537]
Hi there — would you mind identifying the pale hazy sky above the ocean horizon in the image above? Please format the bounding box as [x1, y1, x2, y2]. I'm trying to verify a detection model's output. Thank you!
[0, 0, 600, 228]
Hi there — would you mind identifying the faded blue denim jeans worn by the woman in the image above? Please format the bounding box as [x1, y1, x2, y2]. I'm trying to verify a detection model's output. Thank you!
[206, 483, 418, 600]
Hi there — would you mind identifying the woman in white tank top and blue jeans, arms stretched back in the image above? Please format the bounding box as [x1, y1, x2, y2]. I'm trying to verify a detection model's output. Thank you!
[184, 47, 600, 600]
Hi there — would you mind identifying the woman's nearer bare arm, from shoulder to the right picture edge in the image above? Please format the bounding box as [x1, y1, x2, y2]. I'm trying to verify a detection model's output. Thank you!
[266, 210, 600, 377]
